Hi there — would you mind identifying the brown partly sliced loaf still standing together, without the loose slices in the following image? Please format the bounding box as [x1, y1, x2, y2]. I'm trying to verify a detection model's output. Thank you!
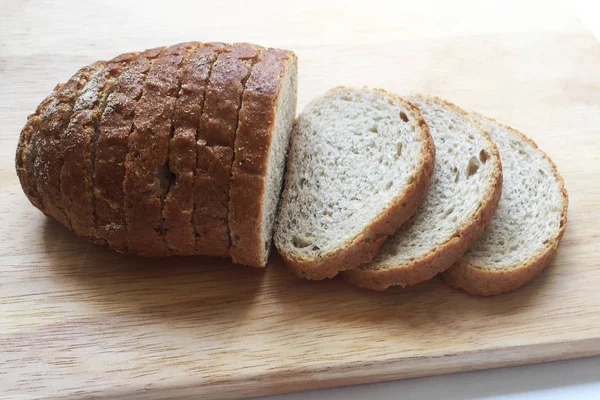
[16, 42, 297, 266]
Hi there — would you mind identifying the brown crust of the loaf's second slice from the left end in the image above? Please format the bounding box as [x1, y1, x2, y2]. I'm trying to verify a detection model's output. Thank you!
[30, 61, 104, 228]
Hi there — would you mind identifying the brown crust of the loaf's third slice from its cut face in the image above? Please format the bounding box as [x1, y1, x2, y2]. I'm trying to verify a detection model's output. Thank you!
[162, 43, 224, 255]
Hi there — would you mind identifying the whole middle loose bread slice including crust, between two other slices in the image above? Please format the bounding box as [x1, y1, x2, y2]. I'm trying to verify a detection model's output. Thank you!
[345, 96, 502, 290]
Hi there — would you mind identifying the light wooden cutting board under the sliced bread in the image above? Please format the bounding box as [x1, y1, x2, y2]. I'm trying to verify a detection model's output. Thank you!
[0, 0, 600, 399]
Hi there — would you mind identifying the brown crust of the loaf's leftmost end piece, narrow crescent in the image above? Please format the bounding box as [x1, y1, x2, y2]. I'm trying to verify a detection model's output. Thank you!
[15, 84, 62, 215]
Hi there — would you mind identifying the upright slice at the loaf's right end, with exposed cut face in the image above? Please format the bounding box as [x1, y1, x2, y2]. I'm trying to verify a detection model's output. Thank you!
[229, 49, 298, 267]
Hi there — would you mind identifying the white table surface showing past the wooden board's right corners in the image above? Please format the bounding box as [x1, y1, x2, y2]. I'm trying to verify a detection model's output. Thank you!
[261, 0, 600, 400]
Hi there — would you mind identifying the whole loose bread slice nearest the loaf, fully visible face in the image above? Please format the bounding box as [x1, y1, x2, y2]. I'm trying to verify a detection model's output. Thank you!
[274, 87, 435, 279]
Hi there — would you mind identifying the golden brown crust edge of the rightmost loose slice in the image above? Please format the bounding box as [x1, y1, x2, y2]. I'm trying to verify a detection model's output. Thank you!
[442, 113, 569, 296]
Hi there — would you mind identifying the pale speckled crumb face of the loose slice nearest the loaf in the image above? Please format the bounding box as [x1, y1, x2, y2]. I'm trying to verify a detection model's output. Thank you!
[275, 88, 426, 260]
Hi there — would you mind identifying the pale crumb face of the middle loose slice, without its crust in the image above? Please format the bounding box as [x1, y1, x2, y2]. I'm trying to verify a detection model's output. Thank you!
[360, 96, 498, 270]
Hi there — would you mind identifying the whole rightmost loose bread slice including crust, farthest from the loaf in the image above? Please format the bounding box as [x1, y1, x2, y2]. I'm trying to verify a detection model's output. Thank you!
[442, 113, 568, 295]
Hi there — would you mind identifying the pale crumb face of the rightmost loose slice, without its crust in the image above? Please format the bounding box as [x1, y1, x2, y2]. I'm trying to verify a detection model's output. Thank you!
[463, 113, 565, 269]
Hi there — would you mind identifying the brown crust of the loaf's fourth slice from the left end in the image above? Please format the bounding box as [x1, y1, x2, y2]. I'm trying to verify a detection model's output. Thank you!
[94, 49, 160, 251]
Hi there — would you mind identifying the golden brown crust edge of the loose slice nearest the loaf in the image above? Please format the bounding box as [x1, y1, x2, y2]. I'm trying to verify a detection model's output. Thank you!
[280, 94, 435, 280]
